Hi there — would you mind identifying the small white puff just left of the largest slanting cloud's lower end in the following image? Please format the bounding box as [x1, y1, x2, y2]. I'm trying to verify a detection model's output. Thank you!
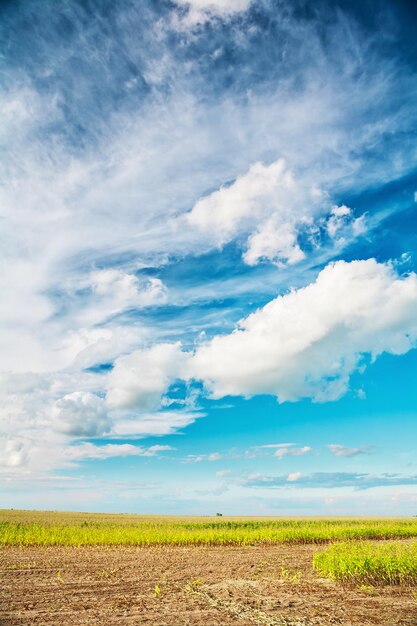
[107, 343, 186, 410]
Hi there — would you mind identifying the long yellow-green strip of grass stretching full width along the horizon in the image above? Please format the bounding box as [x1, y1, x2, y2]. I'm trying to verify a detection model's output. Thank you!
[0, 510, 417, 546]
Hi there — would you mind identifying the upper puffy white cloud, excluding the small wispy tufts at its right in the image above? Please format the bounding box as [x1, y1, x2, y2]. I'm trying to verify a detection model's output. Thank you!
[185, 159, 328, 265]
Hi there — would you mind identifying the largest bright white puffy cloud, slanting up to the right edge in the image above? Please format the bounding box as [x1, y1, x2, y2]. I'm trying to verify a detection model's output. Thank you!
[190, 259, 417, 402]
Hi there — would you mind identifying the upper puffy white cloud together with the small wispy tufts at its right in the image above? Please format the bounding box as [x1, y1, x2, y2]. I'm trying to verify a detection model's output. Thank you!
[184, 158, 366, 267]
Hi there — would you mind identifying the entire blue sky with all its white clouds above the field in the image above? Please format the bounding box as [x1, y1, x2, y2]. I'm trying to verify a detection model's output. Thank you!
[0, 0, 417, 515]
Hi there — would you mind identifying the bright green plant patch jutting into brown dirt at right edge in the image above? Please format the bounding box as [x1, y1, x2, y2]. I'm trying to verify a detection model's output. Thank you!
[313, 542, 417, 585]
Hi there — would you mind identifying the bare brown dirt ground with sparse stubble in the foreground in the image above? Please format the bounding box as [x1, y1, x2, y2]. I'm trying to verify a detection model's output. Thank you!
[0, 545, 417, 626]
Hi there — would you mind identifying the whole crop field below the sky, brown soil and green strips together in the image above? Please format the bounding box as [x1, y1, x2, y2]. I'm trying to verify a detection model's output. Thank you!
[0, 511, 417, 626]
